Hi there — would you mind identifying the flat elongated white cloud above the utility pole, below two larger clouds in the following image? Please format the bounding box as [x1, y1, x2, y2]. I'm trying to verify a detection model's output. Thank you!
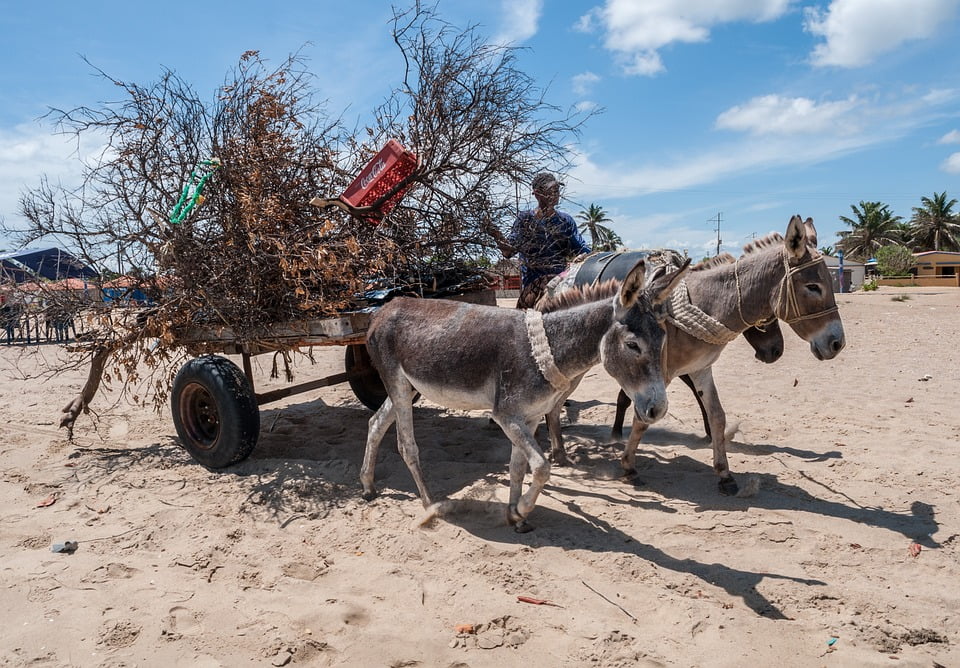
[716, 95, 859, 135]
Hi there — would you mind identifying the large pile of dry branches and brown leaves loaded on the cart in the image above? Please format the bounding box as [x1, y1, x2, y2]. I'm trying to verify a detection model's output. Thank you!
[6, 3, 586, 427]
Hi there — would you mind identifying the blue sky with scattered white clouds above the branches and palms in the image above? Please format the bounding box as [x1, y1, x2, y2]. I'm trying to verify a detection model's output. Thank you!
[0, 0, 960, 257]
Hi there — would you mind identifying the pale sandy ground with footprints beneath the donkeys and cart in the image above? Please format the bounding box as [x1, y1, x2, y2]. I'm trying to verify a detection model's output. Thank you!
[0, 288, 960, 667]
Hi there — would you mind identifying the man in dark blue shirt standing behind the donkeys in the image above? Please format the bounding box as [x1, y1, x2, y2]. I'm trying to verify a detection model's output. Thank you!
[490, 172, 590, 308]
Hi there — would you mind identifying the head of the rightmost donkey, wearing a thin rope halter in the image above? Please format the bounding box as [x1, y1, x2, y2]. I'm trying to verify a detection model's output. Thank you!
[774, 216, 846, 360]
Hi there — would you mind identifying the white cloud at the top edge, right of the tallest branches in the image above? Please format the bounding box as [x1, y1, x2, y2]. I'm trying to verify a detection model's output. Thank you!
[578, 0, 790, 76]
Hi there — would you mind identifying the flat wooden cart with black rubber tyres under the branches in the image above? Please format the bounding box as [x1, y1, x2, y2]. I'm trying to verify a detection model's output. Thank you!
[170, 290, 497, 469]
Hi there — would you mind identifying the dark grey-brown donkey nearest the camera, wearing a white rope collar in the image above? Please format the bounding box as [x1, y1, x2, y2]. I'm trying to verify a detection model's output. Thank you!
[360, 261, 689, 532]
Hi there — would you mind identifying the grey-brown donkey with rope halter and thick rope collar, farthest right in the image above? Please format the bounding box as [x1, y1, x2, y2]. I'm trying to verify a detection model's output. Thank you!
[621, 216, 846, 494]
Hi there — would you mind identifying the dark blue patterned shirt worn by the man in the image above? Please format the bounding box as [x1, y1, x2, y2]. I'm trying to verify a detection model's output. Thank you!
[507, 211, 590, 287]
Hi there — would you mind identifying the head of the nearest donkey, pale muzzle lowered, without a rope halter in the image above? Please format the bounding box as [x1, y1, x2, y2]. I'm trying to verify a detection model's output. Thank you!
[600, 259, 690, 424]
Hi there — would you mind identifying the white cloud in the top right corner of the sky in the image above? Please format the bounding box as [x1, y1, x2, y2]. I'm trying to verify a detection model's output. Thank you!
[804, 0, 960, 67]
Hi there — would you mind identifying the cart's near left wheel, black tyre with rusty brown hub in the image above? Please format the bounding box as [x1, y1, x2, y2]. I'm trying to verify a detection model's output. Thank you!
[170, 355, 260, 469]
